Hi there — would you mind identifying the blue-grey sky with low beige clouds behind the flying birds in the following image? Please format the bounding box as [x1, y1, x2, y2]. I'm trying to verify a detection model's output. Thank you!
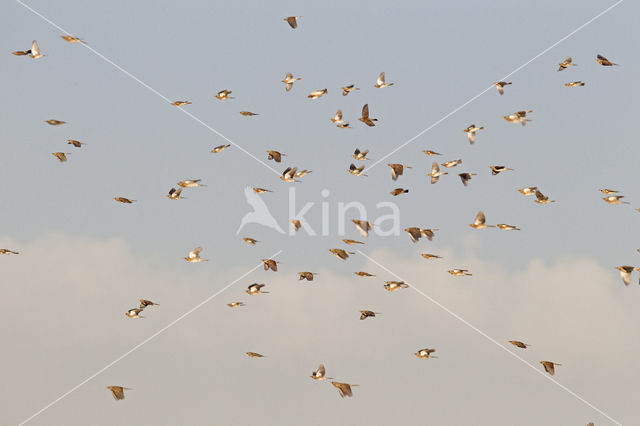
[0, 0, 640, 426]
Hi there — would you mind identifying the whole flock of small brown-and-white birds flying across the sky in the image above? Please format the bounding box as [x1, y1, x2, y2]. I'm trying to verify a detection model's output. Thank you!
[0, 16, 624, 426]
